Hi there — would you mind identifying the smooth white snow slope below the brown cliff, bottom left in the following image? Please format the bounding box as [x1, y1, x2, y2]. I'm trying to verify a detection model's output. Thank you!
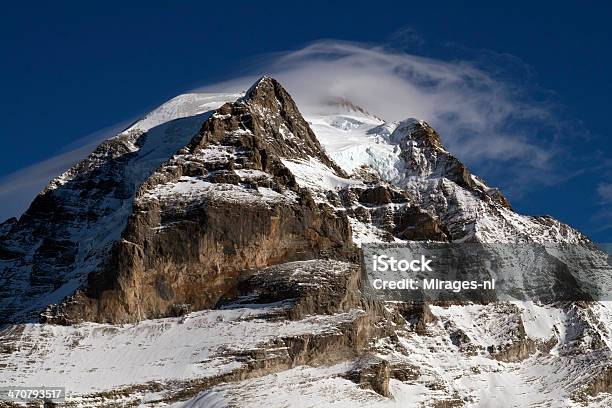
[0, 294, 359, 396]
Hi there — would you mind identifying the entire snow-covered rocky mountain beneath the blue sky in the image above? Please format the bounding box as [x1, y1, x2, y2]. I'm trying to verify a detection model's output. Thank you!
[0, 77, 612, 407]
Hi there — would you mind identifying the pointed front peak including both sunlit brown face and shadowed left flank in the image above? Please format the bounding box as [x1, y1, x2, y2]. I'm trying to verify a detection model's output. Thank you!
[3, 78, 451, 324]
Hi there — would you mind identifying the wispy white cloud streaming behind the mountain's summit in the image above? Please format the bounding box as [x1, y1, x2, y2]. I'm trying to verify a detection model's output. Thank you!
[0, 36, 580, 222]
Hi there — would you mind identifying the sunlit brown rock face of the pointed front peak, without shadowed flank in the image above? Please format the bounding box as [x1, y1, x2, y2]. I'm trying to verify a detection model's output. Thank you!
[47, 78, 351, 323]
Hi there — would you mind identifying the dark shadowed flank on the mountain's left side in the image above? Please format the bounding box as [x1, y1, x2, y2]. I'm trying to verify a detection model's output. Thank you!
[0, 99, 237, 322]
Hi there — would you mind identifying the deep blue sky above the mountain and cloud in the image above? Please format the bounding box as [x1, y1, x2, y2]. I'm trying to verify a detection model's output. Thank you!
[0, 1, 612, 242]
